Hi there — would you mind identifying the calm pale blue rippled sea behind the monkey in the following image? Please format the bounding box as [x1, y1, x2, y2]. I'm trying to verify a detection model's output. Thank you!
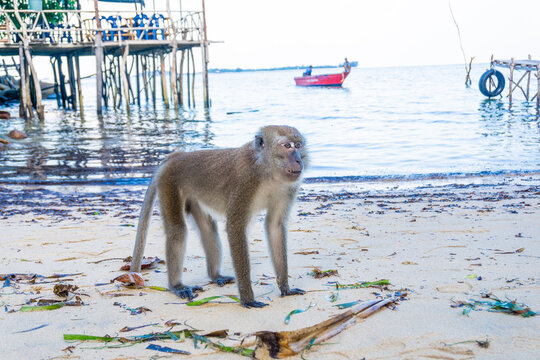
[0, 64, 540, 183]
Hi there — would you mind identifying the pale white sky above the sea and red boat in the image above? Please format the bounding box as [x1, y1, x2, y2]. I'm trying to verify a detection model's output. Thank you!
[182, 0, 540, 68]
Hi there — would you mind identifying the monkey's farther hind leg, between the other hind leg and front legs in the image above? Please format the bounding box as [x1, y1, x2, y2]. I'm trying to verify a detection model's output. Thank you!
[186, 200, 234, 286]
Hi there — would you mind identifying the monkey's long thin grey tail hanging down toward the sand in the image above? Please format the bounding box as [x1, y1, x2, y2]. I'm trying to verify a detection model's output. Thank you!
[130, 170, 160, 272]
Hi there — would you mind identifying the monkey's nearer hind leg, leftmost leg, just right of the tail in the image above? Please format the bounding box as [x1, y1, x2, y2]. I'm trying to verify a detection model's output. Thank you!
[159, 186, 202, 300]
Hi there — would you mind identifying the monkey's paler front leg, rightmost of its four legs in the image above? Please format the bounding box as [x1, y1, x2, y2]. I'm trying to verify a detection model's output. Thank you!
[265, 209, 305, 296]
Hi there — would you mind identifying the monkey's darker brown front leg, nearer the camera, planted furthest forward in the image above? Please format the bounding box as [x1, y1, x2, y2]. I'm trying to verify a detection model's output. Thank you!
[227, 215, 268, 309]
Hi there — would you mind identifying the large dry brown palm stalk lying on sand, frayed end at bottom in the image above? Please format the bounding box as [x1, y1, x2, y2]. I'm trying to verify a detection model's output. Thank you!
[253, 299, 397, 359]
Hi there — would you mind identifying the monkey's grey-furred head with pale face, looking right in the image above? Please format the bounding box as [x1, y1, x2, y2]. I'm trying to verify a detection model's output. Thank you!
[254, 125, 308, 182]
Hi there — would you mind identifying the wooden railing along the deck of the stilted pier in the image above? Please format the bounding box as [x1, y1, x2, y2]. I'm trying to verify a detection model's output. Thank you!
[0, 10, 203, 47]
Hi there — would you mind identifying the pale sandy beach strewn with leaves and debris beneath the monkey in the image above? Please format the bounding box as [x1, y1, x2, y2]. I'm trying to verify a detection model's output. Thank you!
[0, 174, 540, 359]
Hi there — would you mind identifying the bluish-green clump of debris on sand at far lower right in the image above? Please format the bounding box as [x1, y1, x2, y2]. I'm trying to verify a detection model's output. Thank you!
[450, 293, 538, 317]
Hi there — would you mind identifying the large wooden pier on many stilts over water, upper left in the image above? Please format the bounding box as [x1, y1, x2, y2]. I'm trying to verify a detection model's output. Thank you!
[0, 0, 210, 119]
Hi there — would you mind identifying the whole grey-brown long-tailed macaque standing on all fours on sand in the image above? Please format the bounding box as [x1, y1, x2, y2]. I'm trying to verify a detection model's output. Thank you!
[131, 126, 308, 308]
